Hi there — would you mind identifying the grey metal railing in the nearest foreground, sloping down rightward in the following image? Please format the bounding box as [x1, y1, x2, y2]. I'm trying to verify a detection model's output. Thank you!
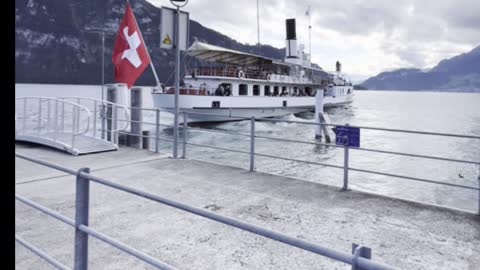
[15, 153, 394, 270]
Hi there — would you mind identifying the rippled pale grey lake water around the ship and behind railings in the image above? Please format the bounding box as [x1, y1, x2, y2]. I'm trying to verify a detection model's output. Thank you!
[15, 84, 480, 211]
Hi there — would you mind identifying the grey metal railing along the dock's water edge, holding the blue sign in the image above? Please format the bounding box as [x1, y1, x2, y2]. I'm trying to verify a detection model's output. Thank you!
[110, 108, 480, 215]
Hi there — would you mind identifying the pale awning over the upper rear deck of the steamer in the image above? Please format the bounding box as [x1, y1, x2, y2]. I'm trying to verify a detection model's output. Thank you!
[187, 41, 285, 66]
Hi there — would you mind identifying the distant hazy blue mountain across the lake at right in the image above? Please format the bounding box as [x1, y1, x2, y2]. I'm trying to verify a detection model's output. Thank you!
[362, 46, 480, 92]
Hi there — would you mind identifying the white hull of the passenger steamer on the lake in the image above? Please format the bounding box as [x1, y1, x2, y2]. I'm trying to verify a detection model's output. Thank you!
[152, 93, 353, 123]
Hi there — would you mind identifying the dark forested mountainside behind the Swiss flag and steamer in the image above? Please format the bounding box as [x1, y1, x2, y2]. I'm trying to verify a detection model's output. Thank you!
[15, 0, 285, 85]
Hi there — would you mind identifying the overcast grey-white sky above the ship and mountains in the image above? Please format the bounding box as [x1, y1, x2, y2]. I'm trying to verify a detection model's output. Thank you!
[148, 0, 480, 80]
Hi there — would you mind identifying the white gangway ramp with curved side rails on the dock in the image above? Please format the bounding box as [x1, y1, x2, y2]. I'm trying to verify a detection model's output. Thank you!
[15, 96, 129, 155]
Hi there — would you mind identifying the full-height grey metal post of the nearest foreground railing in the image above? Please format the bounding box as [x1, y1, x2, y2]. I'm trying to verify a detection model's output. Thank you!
[74, 168, 90, 270]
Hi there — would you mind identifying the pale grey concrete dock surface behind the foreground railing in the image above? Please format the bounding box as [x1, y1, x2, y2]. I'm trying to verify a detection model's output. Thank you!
[15, 143, 480, 270]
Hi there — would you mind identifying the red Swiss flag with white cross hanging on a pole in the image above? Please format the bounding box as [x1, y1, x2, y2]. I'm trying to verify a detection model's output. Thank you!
[112, 4, 150, 89]
